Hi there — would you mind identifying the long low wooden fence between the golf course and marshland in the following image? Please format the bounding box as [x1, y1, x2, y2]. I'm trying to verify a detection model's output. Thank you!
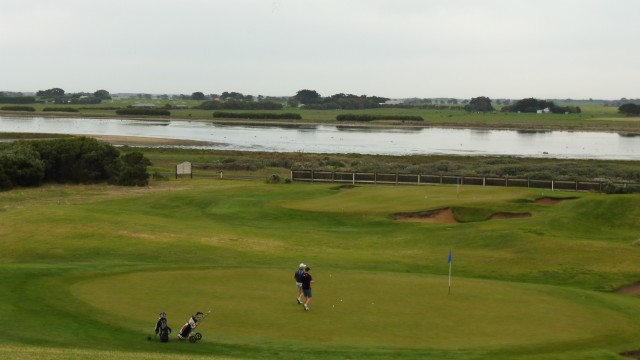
[291, 170, 640, 192]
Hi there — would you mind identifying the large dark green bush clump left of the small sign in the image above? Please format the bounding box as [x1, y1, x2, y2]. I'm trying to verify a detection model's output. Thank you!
[0, 137, 150, 190]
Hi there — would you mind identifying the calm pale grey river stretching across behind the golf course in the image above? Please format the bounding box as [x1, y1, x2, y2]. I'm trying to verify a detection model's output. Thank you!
[0, 116, 640, 160]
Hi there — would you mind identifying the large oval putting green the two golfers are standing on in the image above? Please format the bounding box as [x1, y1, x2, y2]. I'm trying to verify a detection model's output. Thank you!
[71, 269, 638, 350]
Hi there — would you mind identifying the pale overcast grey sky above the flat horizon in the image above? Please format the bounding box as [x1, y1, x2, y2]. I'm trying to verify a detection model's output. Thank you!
[0, 0, 640, 100]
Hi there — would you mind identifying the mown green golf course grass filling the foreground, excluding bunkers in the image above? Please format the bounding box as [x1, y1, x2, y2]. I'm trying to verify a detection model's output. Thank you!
[0, 179, 640, 359]
